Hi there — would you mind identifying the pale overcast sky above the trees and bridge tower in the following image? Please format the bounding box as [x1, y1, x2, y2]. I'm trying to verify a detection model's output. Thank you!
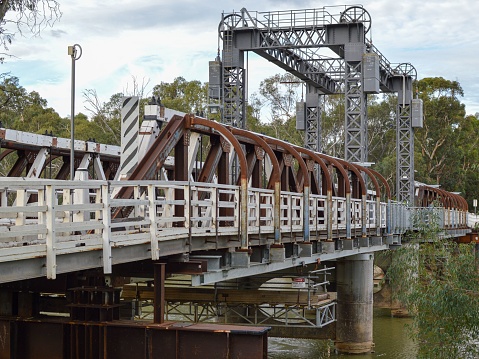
[0, 0, 479, 116]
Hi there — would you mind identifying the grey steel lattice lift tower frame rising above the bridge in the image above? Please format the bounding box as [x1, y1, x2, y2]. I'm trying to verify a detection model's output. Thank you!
[216, 6, 422, 203]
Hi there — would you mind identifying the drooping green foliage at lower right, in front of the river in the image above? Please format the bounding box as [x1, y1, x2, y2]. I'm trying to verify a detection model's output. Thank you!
[388, 208, 479, 358]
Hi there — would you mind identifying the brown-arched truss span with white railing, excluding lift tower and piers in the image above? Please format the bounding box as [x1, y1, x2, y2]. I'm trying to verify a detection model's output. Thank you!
[0, 115, 468, 285]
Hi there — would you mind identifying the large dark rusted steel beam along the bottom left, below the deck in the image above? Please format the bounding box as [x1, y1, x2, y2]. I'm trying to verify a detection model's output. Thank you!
[0, 318, 271, 359]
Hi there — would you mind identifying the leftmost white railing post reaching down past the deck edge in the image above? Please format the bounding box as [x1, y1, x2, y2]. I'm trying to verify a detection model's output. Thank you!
[45, 185, 57, 279]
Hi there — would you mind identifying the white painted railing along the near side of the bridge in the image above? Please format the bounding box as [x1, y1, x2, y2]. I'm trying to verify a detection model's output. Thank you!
[0, 178, 467, 278]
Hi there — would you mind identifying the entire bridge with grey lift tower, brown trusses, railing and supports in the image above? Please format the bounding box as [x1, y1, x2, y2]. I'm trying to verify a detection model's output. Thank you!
[0, 6, 470, 358]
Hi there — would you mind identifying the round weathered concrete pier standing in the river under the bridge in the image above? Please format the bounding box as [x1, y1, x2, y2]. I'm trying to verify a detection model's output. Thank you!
[335, 254, 374, 354]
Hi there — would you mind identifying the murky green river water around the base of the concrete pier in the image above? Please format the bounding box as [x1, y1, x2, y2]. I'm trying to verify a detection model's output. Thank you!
[268, 309, 417, 359]
